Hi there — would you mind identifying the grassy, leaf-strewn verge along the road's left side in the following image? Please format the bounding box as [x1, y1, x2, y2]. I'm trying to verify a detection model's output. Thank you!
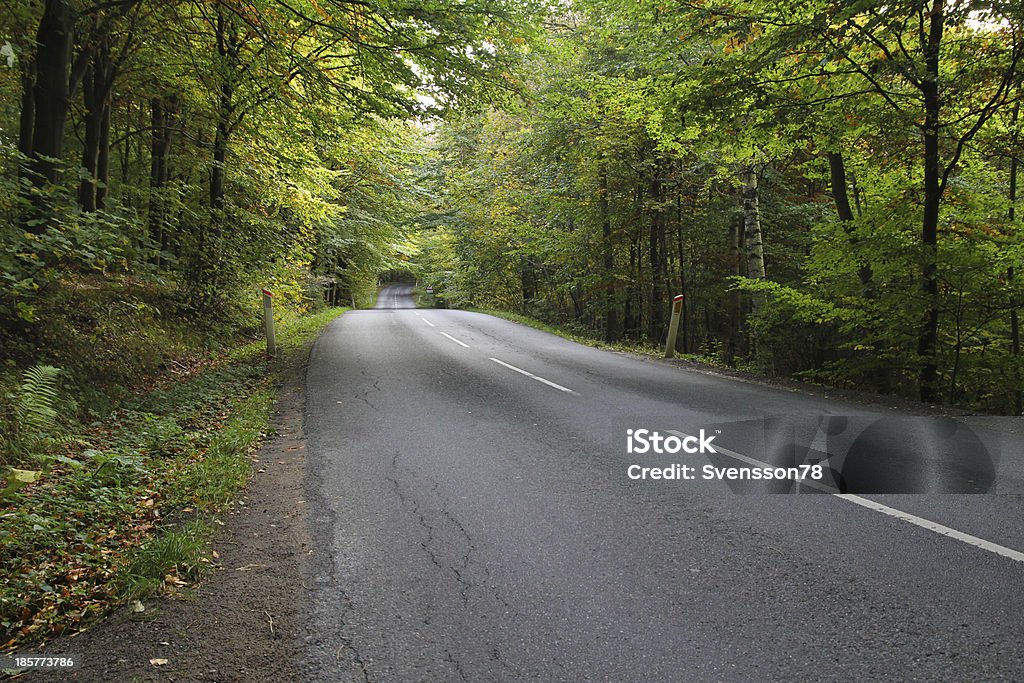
[0, 308, 347, 651]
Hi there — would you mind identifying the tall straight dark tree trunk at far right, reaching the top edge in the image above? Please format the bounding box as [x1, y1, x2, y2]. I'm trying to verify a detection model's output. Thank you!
[918, 0, 944, 401]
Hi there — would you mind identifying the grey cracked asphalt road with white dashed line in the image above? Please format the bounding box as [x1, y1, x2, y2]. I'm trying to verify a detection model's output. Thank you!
[304, 287, 1024, 682]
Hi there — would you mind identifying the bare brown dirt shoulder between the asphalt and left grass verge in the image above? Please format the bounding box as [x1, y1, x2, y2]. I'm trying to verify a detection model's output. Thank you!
[18, 342, 312, 683]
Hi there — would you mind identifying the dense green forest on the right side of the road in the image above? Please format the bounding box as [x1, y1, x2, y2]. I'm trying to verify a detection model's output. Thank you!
[413, 0, 1024, 414]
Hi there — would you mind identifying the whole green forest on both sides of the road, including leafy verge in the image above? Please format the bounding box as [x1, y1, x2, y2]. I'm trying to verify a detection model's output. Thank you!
[0, 0, 1024, 645]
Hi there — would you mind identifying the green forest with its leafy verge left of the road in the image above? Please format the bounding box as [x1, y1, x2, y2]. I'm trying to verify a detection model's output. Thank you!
[0, 0, 542, 651]
